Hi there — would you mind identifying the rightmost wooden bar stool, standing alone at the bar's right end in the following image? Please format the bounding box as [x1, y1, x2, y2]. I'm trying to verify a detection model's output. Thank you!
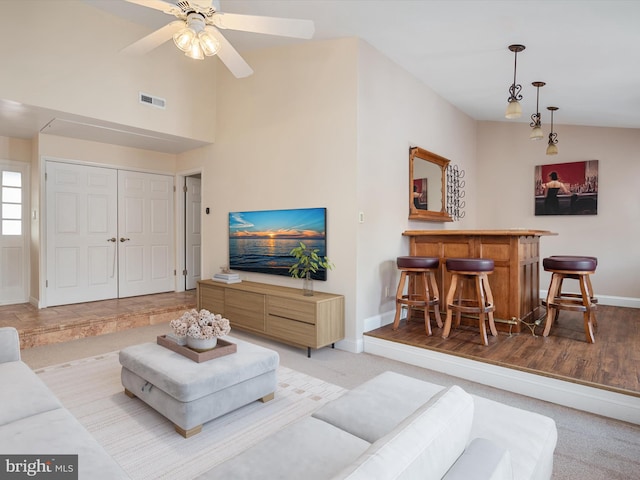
[542, 255, 598, 343]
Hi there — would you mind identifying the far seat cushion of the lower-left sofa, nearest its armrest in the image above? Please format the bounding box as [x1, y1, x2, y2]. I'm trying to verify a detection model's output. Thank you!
[0, 362, 62, 425]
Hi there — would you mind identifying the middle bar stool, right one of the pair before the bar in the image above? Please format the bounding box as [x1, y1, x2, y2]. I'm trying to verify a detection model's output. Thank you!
[442, 258, 498, 345]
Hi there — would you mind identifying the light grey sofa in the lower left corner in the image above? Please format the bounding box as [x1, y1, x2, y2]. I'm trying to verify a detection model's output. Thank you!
[0, 327, 129, 480]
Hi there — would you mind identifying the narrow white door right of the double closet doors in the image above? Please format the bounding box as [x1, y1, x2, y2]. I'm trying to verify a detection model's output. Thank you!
[184, 177, 202, 290]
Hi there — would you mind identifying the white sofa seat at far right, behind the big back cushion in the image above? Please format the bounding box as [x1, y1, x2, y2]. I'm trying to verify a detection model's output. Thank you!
[471, 395, 558, 480]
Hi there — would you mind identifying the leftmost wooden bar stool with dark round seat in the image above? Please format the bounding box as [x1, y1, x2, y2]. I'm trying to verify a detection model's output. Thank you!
[393, 257, 442, 335]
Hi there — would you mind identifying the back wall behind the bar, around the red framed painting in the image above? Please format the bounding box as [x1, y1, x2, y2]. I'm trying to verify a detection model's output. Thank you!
[477, 122, 640, 307]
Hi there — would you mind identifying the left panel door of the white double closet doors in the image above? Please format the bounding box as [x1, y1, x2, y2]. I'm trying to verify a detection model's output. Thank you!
[45, 162, 118, 306]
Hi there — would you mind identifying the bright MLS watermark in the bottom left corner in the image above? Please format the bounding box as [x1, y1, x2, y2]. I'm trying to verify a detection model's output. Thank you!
[0, 454, 78, 480]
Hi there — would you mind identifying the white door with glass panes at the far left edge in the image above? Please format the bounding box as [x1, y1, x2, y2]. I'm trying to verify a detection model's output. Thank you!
[0, 160, 29, 305]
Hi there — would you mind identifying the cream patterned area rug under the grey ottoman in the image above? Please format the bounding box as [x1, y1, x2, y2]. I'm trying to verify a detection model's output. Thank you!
[36, 352, 345, 480]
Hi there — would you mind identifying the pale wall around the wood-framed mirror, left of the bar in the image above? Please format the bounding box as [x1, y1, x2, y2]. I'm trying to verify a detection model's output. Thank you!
[351, 42, 476, 338]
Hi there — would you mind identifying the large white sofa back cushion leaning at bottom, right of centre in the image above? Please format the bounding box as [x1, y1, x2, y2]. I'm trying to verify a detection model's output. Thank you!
[334, 385, 474, 480]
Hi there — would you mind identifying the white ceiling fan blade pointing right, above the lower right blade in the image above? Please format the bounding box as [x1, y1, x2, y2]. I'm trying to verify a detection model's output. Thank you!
[212, 13, 315, 38]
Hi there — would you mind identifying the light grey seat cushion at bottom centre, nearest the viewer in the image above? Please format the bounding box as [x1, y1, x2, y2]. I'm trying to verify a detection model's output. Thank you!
[197, 417, 369, 480]
